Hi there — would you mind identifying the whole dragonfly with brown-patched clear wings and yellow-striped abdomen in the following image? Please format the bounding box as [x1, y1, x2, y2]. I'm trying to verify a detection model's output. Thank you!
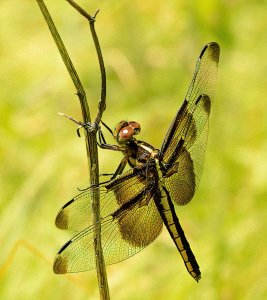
[54, 42, 220, 281]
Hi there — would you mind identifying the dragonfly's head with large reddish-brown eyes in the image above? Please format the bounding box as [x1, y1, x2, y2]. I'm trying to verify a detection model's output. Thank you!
[113, 120, 141, 144]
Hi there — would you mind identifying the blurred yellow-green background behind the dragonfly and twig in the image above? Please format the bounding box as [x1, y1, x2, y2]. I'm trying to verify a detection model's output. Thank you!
[0, 0, 267, 300]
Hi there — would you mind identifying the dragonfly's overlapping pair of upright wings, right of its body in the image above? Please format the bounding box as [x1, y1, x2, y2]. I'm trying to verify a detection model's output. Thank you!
[160, 43, 220, 205]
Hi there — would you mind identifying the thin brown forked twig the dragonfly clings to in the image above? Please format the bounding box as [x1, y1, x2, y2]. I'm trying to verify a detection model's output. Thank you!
[36, 0, 109, 299]
